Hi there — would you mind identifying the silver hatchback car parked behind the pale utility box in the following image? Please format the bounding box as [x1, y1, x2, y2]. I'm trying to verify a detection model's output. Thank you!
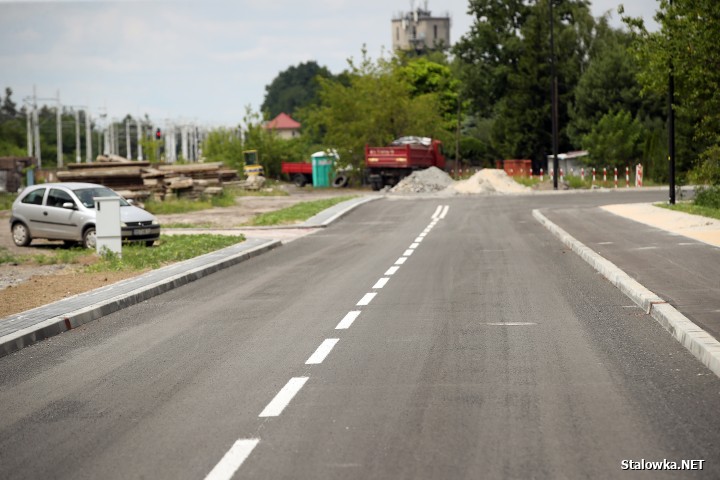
[10, 182, 160, 248]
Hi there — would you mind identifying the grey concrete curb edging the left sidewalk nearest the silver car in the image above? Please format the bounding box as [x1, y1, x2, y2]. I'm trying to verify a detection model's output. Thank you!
[0, 240, 282, 356]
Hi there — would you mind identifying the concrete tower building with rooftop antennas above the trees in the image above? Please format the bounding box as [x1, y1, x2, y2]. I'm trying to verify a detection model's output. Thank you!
[392, 0, 450, 51]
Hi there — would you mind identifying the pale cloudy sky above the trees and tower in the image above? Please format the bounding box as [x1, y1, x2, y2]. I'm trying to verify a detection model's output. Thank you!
[0, 0, 657, 127]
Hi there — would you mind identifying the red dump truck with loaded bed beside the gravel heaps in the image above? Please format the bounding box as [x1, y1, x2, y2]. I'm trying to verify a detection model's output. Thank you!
[365, 137, 445, 190]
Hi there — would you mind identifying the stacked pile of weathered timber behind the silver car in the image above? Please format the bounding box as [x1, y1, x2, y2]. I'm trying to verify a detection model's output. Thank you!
[57, 156, 238, 201]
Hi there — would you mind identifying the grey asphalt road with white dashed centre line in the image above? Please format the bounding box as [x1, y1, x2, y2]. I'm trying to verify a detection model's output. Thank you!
[0, 192, 720, 479]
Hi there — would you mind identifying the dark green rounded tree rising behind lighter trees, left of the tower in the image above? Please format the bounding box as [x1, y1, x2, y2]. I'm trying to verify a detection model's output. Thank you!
[260, 61, 332, 118]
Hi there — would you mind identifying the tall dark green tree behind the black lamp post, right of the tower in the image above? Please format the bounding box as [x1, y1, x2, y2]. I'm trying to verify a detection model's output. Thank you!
[455, 0, 595, 167]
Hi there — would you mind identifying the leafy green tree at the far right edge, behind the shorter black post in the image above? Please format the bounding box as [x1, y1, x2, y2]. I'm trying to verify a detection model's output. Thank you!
[620, 0, 720, 181]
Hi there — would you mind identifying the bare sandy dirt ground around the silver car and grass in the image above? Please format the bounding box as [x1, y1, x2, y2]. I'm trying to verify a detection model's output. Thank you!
[0, 185, 365, 318]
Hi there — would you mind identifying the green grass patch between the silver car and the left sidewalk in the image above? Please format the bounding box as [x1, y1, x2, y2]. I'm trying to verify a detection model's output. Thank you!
[86, 235, 245, 272]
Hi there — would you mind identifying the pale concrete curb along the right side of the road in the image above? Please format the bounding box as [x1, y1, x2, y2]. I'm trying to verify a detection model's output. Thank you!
[532, 210, 720, 377]
